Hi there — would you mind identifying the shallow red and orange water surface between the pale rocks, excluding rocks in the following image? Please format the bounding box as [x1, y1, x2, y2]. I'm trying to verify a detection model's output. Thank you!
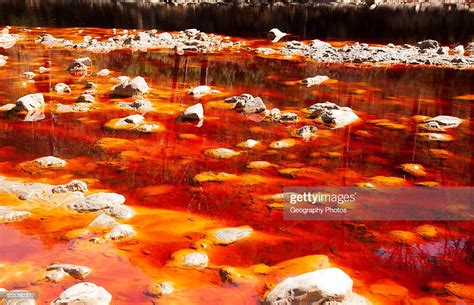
[0, 28, 474, 304]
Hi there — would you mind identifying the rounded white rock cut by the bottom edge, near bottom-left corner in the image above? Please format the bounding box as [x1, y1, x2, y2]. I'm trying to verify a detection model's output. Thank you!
[51, 282, 112, 305]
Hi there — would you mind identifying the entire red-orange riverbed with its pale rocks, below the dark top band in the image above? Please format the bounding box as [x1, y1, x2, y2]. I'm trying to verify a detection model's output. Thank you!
[0, 27, 474, 305]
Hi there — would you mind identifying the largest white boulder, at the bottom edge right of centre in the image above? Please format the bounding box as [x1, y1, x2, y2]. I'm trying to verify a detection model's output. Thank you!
[264, 268, 353, 305]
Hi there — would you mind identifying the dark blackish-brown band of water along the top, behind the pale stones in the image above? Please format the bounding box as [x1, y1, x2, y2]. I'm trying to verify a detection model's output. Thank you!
[0, 0, 474, 43]
